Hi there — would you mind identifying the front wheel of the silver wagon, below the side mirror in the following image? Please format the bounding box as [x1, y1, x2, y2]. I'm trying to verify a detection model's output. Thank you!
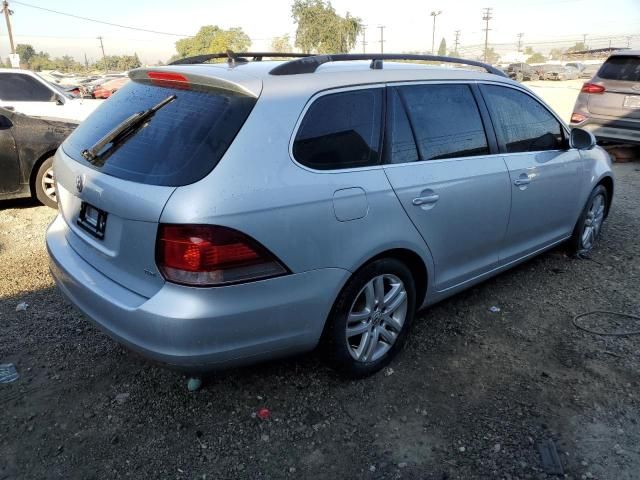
[567, 185, 609, 257]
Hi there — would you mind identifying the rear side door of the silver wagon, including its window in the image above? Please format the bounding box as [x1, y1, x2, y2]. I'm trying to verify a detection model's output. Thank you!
[384, 83, 511, 291]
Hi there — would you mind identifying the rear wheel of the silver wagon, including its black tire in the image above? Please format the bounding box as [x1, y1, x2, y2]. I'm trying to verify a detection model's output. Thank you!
[324, 258, 416, 378]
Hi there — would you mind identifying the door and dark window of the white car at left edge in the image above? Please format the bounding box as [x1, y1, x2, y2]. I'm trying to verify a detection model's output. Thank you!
[0, 72, 63, 117]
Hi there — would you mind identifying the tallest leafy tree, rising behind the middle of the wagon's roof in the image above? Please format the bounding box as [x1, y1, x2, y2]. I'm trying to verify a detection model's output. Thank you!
[291, 0, 362, 53]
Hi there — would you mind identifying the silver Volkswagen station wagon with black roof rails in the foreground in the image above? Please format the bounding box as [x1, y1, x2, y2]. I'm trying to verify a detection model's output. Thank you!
[47, 53, 614, 377]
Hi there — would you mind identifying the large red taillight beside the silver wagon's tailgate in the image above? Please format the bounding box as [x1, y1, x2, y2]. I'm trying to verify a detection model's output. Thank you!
[156, 225, 286, 286]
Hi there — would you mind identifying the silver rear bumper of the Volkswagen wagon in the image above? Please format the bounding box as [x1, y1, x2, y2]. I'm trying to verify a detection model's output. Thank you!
[47, 216, 350, 371]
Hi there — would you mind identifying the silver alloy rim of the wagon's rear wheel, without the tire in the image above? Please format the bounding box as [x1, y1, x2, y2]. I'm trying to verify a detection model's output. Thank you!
[346, 274, 408, 362]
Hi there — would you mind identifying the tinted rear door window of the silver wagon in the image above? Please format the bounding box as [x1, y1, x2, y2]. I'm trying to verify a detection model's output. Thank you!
[392, 85, 489, 162]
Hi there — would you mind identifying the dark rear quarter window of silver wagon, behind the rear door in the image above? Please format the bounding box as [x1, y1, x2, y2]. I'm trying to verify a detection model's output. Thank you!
[293, 88, 382, 170]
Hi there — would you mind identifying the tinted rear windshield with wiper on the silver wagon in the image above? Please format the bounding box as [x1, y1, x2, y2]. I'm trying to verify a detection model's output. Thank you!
[62, 81, 256, 186]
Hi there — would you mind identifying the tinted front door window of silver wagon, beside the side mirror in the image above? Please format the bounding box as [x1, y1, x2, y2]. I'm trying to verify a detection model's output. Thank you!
[482, 85, 564, 153]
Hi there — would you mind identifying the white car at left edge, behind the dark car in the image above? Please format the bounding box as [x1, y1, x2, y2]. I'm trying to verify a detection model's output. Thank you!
[0, 68, 101, 122]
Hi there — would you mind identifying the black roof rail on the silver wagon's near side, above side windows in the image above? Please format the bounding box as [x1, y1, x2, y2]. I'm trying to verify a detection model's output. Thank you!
[269, 53, 507, 77]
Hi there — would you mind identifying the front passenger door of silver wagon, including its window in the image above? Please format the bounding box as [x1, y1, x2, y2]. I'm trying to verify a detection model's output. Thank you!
[481, 84, 582, 263]
